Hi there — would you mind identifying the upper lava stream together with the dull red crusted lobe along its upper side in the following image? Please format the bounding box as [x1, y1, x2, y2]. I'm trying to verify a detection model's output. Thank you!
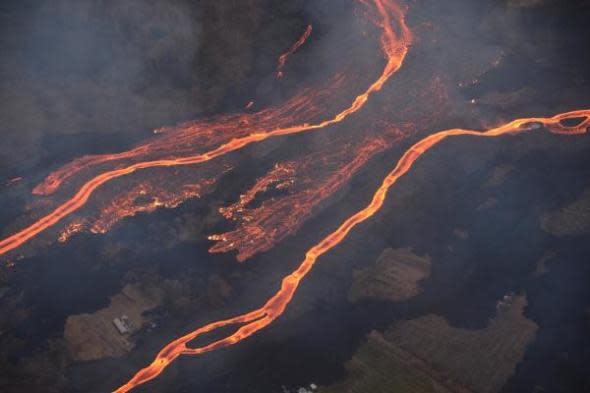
[0, 0, 412, 255]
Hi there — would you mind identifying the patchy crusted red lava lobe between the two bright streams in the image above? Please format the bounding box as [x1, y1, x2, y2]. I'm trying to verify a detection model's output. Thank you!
[209, 137, 392, 262]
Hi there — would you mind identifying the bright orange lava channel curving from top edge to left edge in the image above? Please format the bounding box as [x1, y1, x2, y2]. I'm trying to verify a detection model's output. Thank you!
[0, 0, 412, 255]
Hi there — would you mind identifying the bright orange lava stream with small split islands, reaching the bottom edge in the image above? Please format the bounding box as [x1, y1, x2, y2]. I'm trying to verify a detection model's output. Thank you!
[116, 109, 590, 393]
